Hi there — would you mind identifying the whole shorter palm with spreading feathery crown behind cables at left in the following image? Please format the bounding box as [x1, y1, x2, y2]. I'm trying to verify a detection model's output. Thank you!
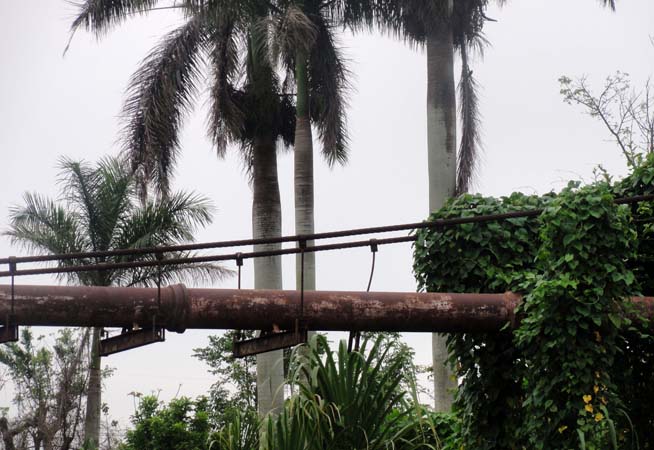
[5, 158, 227, 448]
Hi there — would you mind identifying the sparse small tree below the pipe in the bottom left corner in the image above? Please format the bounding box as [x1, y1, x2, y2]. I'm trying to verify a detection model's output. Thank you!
[0, 328, 90, 450]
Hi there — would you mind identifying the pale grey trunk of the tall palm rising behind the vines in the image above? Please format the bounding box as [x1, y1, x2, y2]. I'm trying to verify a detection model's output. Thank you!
[427, 7, 456, 411]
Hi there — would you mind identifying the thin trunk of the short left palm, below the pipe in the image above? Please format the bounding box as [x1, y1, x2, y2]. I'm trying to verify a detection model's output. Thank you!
[84, 328, 102, 448]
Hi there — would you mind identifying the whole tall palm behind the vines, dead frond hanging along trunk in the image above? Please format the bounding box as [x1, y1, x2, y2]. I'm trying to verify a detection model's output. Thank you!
[372, 0, 615, 411]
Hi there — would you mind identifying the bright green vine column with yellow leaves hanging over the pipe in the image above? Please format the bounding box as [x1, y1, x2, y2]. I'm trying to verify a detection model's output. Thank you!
[516, 183, 635, 449]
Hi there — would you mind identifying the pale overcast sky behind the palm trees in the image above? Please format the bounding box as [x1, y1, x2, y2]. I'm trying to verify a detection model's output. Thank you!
[0, 0, 654, 420]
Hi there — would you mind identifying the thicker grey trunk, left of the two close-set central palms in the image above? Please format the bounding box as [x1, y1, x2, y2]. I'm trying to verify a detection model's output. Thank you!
[252, 137, 284, 417]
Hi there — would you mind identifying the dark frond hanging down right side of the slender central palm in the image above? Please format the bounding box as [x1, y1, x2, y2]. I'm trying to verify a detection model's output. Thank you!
[309, 15, 351, 165]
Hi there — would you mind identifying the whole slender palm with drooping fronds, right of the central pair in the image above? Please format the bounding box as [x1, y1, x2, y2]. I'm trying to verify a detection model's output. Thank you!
[271, 0, 348, 298]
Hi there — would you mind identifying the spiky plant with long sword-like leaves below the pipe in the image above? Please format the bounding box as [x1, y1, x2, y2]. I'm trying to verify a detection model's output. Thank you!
[266, 335, 440, 450]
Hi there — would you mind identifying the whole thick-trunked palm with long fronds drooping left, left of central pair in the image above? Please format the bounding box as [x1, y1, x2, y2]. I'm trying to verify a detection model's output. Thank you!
[72, 0, 295, 415]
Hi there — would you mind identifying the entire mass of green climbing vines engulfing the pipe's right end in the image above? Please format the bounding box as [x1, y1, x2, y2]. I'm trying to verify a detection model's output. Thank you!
[414, 157, 654, 450]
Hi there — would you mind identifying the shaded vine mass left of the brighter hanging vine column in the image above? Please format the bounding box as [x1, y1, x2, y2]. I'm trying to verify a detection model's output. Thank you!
[414, 193, 551, 450]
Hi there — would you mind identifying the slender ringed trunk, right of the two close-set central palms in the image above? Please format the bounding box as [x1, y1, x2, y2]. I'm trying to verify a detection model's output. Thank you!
[294, 52, 316, 302]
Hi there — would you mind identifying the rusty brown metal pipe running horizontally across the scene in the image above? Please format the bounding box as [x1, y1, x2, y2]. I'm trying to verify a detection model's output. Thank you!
[0, 285, 654, 333]
